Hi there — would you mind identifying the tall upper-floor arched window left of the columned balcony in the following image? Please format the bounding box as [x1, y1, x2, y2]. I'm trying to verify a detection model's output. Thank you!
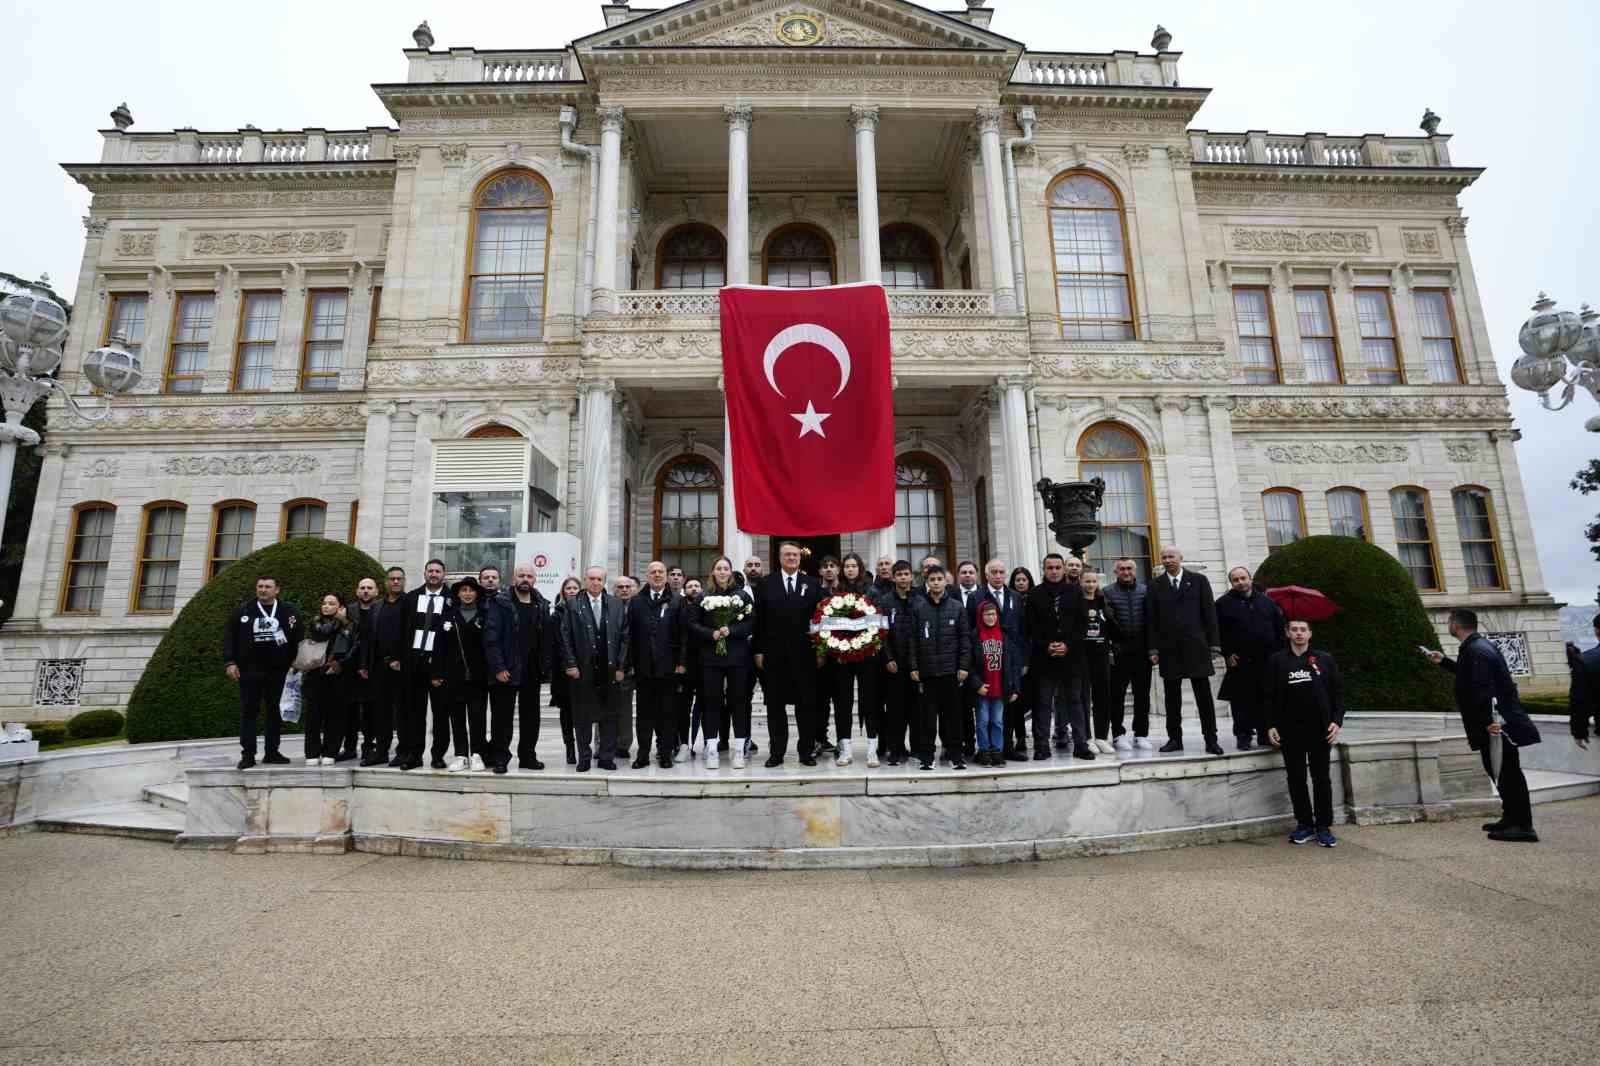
[466, 170, 550, 341]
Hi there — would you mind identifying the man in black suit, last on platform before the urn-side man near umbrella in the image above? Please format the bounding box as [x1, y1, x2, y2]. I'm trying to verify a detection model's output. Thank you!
[1144, 547, 1222, 755]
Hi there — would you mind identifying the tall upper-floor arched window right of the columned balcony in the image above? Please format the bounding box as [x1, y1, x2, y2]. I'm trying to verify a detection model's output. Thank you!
[1050, 171, 1134, 341]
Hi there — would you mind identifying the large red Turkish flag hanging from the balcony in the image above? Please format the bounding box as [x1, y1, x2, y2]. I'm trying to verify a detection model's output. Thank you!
[722, 283, 894, 536]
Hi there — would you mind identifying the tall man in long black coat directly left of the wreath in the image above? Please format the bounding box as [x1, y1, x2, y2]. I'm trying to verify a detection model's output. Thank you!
[755, 541, 822, 767]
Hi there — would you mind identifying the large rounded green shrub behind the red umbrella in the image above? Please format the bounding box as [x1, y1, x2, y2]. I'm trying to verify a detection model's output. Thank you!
[1254, 536, 1454, 712]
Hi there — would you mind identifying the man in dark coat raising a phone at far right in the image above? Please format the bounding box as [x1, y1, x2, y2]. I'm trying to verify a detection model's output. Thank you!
[1427, 608, 1539, 844]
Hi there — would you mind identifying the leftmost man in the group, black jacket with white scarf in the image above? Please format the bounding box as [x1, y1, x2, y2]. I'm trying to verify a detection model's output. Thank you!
[222, 575, 304, 770]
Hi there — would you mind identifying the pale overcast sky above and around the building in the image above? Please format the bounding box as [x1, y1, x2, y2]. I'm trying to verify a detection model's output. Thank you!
[0, 0, 1600, 603]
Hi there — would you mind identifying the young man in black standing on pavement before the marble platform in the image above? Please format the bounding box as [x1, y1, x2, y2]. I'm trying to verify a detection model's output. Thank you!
[1262, 619, 1344, 848]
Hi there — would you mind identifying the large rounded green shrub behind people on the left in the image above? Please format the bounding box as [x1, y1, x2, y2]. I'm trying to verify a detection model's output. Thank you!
[128, 538, 384, 744]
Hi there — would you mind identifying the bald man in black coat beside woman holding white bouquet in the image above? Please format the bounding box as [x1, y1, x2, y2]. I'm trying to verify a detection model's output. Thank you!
[627, 559, 686, 770]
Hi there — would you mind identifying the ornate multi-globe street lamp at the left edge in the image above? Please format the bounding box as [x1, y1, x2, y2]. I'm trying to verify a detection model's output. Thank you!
[0, 284, 144, 520]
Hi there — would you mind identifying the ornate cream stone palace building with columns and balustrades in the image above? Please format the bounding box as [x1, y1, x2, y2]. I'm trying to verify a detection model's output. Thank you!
[0, 0, 1562, 717]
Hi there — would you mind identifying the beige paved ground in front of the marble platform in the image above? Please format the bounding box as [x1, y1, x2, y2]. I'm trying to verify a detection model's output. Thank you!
[0, 799, 1600, 1066]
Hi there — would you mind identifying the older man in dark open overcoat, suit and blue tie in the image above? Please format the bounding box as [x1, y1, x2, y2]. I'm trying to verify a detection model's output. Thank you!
[560, 567, 629, 773]
